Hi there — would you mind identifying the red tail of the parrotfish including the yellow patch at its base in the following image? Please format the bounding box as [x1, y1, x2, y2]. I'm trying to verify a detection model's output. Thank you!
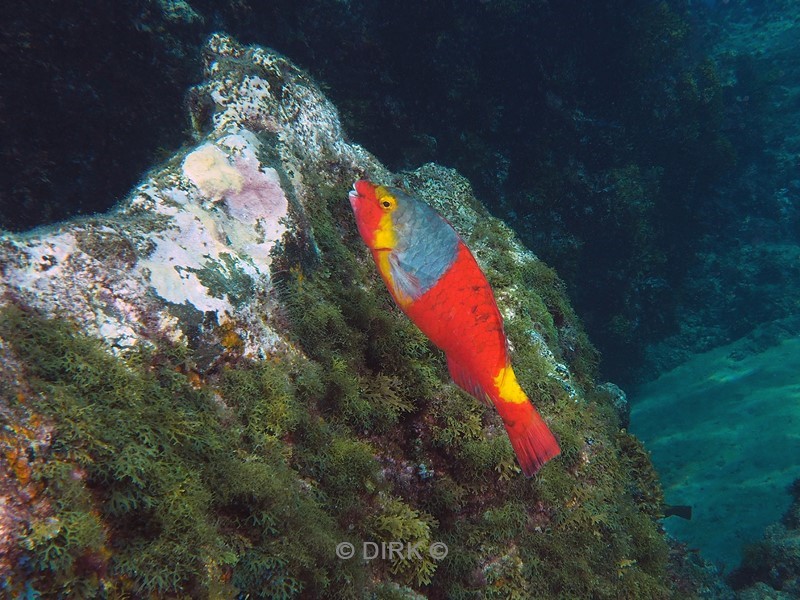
[492, 367, 561, 477]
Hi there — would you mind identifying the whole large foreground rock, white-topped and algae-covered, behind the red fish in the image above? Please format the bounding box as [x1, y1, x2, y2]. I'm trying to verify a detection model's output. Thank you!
[0, 35, 684, 598]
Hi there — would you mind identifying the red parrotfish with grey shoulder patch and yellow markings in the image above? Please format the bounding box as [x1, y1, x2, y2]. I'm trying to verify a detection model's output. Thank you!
[350, 180, 560, 477]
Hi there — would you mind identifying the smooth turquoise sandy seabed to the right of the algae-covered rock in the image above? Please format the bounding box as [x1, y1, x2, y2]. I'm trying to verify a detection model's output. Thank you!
[631, 337, 800, 570]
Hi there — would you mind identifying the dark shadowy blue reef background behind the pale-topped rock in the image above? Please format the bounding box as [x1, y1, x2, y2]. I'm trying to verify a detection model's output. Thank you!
[7, 0, 800, 394]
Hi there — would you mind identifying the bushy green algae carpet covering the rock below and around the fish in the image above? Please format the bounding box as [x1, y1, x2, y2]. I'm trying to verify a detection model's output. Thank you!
[0, 174, 670, 598]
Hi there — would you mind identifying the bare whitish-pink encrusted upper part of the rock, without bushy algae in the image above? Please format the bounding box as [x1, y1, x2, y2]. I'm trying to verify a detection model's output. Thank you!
[0, 36, 380, 360]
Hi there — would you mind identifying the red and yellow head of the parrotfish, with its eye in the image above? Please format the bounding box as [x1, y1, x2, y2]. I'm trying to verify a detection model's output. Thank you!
[349, 179, 402, 252]
